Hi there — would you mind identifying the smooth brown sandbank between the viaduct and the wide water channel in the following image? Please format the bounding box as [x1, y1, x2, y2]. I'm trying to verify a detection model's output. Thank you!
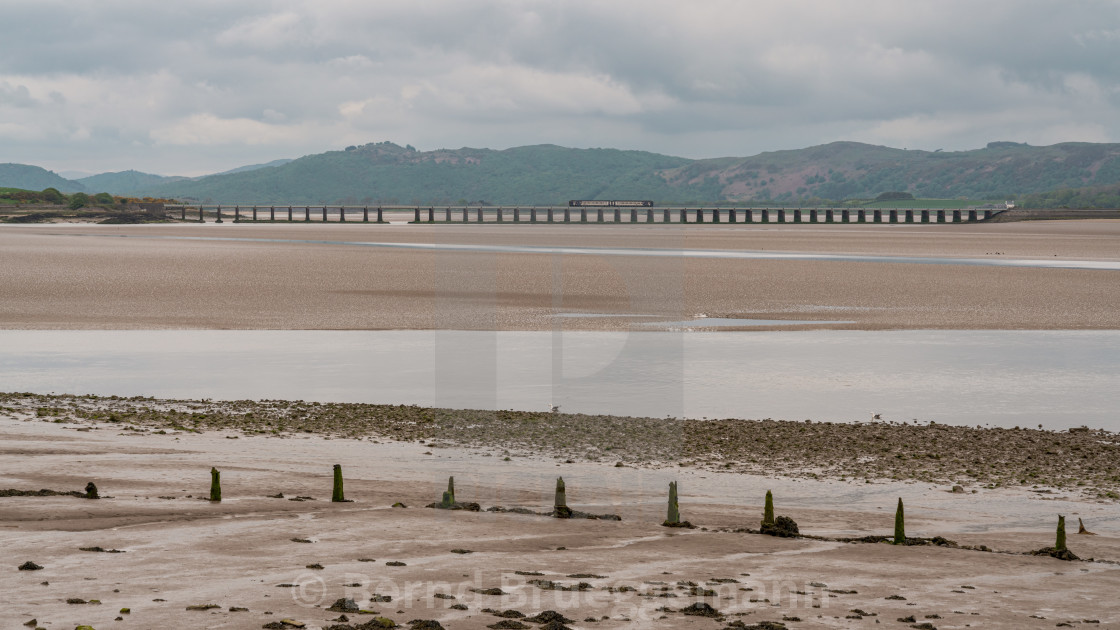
[0, 221, 1120, 330]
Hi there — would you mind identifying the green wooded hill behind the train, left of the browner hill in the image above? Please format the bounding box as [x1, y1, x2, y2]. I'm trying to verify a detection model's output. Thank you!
[135, 142, 703, 204]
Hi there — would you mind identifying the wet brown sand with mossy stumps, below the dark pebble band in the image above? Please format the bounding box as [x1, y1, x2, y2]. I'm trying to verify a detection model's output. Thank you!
[0, 401, 1120, 630]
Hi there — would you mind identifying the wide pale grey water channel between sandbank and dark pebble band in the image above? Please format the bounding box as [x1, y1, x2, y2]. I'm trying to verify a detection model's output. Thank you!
[0, 330, 1120, 430]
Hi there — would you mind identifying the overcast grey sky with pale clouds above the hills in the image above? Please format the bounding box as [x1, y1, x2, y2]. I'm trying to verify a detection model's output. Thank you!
[0, 0, 1120, 175]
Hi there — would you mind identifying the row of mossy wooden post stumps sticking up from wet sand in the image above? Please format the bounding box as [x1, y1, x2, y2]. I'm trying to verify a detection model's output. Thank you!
[206, 464, 1090, 560]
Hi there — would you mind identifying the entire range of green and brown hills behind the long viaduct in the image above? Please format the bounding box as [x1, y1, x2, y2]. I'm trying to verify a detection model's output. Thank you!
[0, 142, 1120, 204]
